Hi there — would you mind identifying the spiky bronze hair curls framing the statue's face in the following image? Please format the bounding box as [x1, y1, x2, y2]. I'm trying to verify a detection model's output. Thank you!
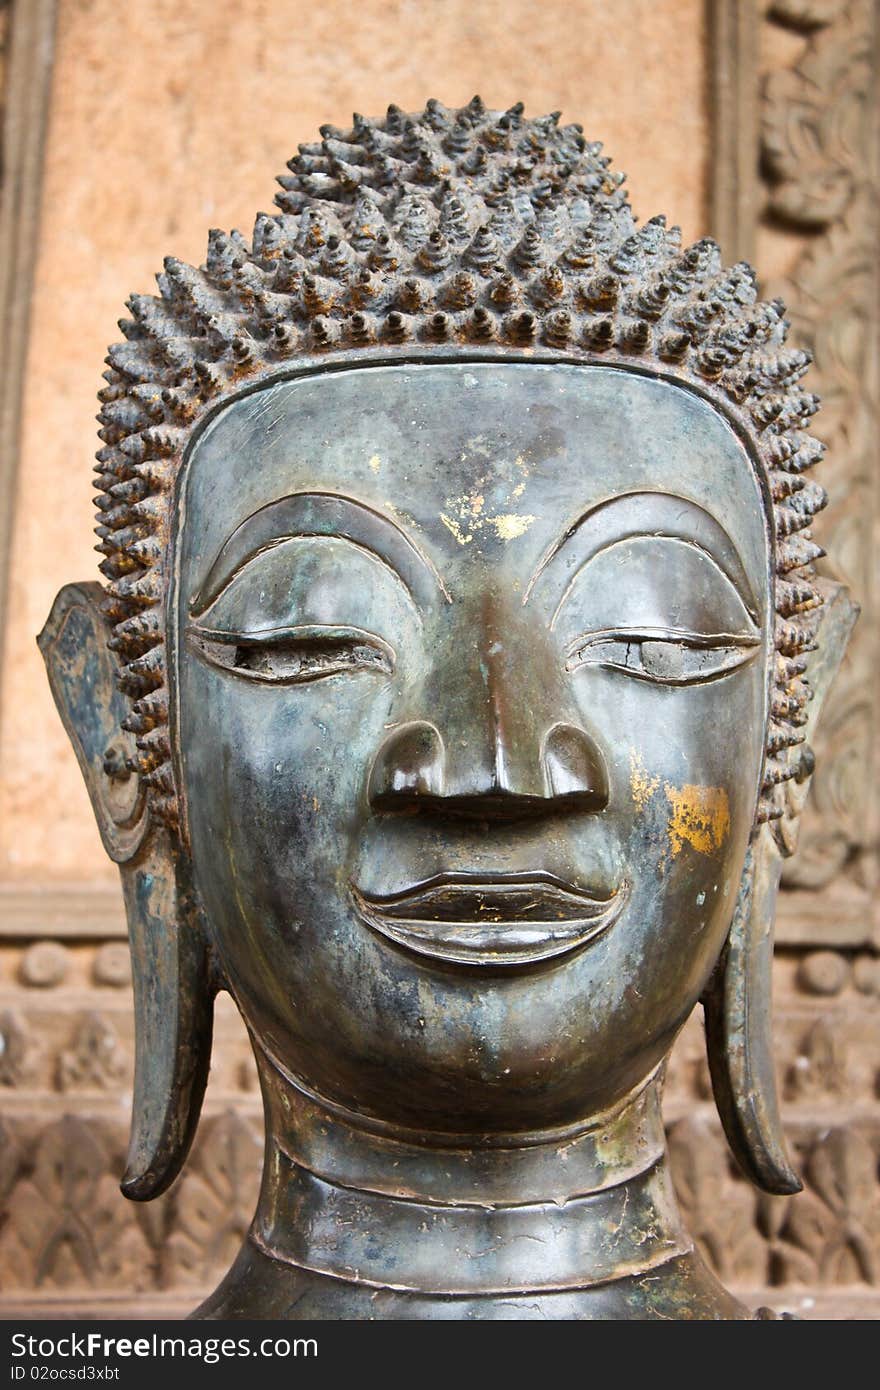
[96, 97, 826, 827]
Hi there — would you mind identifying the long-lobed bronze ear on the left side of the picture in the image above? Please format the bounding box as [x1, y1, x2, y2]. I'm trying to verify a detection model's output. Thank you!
[38, 584, 215, 1201]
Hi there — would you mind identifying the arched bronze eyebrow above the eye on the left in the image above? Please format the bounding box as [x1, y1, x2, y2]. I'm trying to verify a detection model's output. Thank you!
[190, 492, 452, 619]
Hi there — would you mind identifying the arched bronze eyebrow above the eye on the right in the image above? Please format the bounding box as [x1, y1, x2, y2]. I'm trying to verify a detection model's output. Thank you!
[523, 492, 758, 623]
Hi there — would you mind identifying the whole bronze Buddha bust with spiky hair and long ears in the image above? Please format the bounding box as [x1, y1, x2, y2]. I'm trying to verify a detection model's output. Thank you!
[40, 99, 854, 1319]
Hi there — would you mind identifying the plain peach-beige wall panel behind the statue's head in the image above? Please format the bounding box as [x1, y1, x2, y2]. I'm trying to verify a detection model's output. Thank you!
[0, 0, 708, 883]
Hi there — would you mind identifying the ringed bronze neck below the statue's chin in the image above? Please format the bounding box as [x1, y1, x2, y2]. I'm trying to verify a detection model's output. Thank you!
[241, 1058, 691, 1298]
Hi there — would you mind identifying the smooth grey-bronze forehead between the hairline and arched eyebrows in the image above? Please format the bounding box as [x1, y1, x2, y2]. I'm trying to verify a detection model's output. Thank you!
[179, 361, 767, 588]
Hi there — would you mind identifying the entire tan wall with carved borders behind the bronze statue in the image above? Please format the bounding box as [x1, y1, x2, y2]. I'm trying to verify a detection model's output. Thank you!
[0, 0, 880, 1318]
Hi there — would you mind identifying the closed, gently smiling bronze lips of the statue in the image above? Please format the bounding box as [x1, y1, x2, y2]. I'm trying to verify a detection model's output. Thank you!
[352, 870, 627, 966]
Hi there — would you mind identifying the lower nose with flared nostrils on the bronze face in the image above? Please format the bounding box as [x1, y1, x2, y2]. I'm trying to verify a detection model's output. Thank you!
[370, 720, 608, 819]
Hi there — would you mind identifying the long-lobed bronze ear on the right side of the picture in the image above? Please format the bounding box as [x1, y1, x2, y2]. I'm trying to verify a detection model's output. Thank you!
[703, 580, 858, 1194]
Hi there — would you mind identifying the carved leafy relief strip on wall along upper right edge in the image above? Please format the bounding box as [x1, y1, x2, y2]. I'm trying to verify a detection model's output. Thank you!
[759, 0, 880, 891]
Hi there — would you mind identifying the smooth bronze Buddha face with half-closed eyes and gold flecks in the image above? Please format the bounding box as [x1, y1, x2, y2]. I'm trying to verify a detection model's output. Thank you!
[170, 361, 772, 1133]
